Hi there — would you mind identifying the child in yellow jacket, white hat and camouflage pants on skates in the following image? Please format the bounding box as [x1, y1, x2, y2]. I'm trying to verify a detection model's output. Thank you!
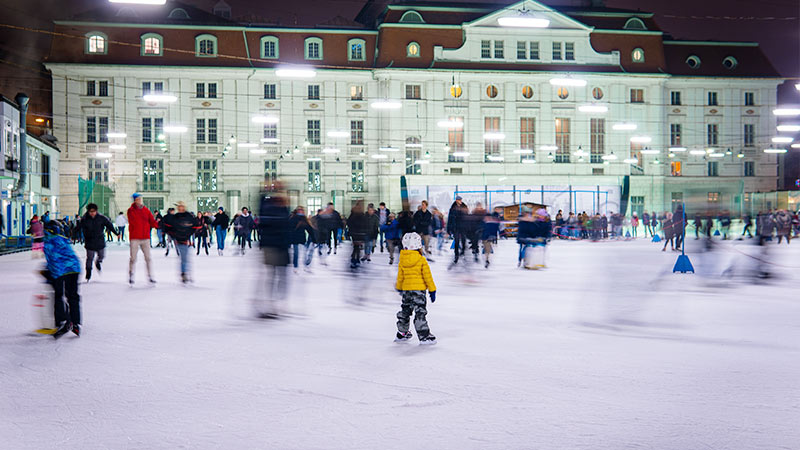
[395, 233, 436, 345]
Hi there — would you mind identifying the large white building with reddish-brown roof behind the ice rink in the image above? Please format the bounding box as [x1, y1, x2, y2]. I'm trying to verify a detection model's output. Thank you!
[47, 1, 782, 218]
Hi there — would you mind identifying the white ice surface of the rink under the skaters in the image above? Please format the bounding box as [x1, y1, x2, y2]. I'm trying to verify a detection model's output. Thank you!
[0, 239, 800, 450]
